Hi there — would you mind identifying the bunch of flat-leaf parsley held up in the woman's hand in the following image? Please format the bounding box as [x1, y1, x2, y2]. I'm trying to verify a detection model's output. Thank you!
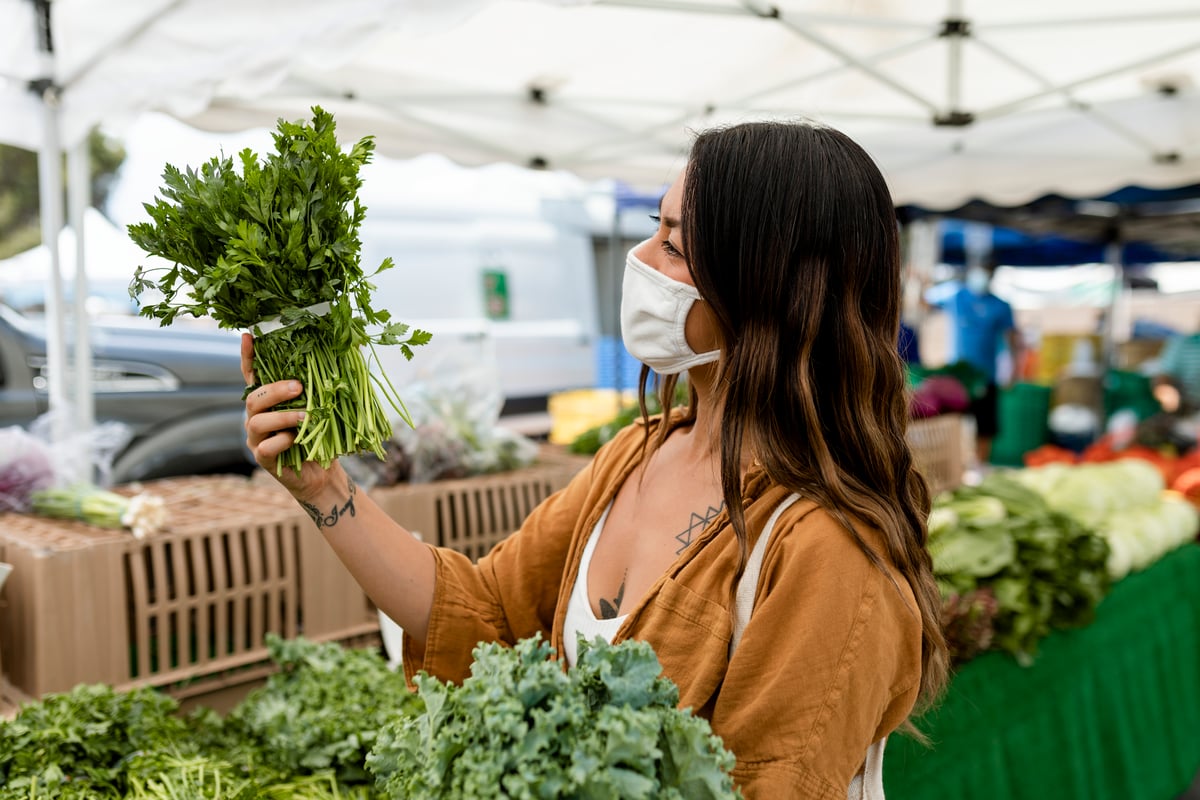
[128, 107, 430, 470]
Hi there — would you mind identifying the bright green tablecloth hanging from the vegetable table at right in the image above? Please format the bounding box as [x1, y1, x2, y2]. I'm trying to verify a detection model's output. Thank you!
[883, 545, 1200, 800]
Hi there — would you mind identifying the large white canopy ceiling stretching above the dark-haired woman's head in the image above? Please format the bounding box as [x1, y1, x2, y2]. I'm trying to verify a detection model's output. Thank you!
[174, 0, 1200, 207]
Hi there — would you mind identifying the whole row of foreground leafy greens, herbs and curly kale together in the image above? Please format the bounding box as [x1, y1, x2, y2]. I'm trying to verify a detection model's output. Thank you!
[0, 637, 739, 800]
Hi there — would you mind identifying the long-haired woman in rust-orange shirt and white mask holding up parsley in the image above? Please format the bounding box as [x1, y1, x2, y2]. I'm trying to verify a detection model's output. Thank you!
[242, 124, 946, 800]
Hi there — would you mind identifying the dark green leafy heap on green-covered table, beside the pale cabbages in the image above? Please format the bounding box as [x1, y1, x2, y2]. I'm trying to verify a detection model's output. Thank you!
[929, 473, 1112, 663]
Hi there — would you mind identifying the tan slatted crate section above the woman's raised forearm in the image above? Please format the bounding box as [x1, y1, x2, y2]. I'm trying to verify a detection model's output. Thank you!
[371, 449, 588, 560]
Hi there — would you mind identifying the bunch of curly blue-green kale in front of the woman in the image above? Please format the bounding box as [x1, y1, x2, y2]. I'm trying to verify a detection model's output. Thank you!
[367, 637, 740, 800]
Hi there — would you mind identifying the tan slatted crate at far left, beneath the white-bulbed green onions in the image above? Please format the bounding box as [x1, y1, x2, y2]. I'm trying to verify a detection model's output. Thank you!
[0, 476, 378, 697]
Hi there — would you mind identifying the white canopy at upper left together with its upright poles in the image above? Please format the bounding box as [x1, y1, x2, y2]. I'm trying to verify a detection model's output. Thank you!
[0, 0, 486, 450]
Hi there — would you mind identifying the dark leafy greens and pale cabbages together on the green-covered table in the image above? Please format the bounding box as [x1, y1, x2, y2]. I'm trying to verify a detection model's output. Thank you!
[929, 446, 1200, 662]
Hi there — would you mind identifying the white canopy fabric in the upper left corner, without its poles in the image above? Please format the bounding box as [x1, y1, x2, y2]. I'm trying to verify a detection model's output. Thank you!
[0, 0, 485, 150]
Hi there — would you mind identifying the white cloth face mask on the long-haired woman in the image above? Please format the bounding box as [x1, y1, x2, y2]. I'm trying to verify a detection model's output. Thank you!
[620, 251, 721, 375]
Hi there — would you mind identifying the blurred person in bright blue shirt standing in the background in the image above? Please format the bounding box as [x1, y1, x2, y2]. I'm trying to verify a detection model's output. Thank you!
[934, 263, 1021, 464]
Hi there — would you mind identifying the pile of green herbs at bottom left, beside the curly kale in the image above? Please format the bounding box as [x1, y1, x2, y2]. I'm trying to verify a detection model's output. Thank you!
[0, 637, 408, 800]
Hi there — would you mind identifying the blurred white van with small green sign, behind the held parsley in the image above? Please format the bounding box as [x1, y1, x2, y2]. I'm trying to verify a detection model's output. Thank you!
[352, 156, 599, 414]
